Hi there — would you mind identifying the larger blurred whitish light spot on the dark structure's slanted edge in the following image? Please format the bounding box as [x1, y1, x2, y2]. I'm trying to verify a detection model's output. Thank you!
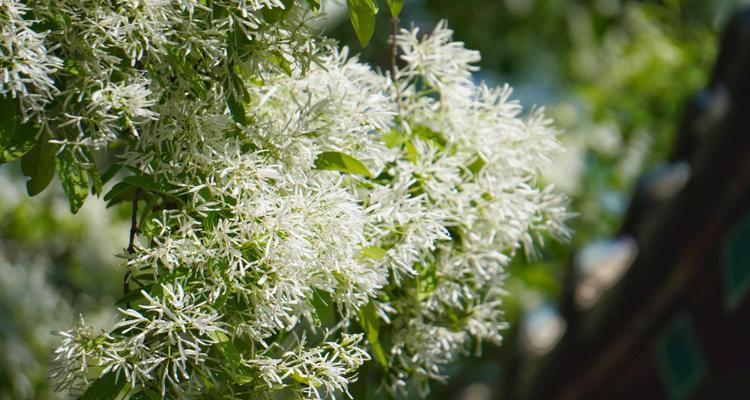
[575, 237, 638, 309]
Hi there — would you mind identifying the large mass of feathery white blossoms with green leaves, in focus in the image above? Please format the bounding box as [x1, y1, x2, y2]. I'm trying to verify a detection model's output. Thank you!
[0, 0, 568, 399]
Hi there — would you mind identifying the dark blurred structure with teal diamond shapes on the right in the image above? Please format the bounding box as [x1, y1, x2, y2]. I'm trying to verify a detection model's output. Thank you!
[506, 9, 750, 400]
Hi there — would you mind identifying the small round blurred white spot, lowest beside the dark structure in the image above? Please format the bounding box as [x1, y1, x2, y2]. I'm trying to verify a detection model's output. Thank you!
[521, 304, 566, 356]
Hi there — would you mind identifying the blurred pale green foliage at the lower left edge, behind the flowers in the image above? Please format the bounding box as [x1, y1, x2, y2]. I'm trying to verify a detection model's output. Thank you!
[0, 168, 129, 400]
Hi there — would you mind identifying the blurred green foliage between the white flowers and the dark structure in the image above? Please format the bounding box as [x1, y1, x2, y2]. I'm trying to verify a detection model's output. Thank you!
[331, 0, 743, 399]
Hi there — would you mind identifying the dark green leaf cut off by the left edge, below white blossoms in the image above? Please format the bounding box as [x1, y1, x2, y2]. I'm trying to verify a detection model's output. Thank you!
[0, 96, 38, 164]
